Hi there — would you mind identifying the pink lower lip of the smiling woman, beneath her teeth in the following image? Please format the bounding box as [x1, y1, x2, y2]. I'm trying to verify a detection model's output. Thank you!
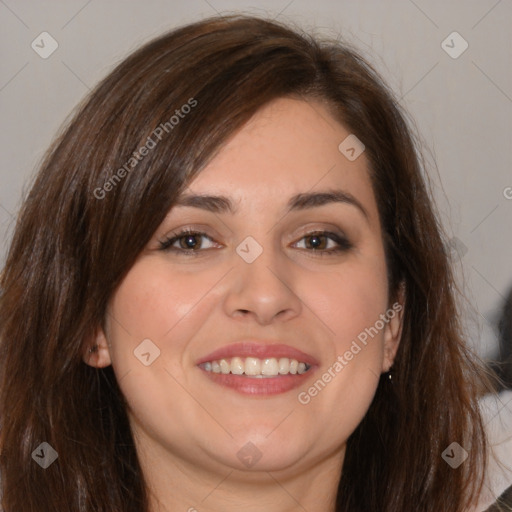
[201, 367, 313, 396]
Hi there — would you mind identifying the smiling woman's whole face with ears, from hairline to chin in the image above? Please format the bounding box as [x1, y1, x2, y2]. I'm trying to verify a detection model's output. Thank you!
[88, 99, 400, 480]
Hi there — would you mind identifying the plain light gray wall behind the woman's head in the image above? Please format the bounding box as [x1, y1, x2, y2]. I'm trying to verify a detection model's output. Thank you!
[0, 0, 512, 356]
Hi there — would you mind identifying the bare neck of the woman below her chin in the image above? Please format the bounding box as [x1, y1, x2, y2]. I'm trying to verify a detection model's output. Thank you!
[137, 434, 344, 512]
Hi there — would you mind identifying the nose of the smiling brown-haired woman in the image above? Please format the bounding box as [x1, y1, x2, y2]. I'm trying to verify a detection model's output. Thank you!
[224, 240, 303, 325]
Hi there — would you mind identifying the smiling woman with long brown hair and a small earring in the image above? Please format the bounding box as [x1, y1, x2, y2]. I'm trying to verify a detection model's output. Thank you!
[0, 16, 494, 512]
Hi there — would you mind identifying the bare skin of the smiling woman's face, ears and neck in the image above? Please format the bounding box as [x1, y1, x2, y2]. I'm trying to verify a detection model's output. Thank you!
[84, 98, 401, 512]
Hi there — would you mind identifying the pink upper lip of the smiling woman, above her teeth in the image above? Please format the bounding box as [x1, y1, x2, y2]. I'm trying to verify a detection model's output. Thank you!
[196, 340, 319, 366]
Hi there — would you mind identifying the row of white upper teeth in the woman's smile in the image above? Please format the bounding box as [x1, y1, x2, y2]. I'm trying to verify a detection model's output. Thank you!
[201, 357, 310, 377]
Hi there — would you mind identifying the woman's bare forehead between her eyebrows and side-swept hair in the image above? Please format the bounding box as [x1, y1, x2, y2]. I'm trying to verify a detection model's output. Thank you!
[182, 98, 377, 217]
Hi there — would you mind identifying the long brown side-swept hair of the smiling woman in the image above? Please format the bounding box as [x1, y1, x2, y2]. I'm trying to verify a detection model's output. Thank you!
[0, 16, 485, 512]
